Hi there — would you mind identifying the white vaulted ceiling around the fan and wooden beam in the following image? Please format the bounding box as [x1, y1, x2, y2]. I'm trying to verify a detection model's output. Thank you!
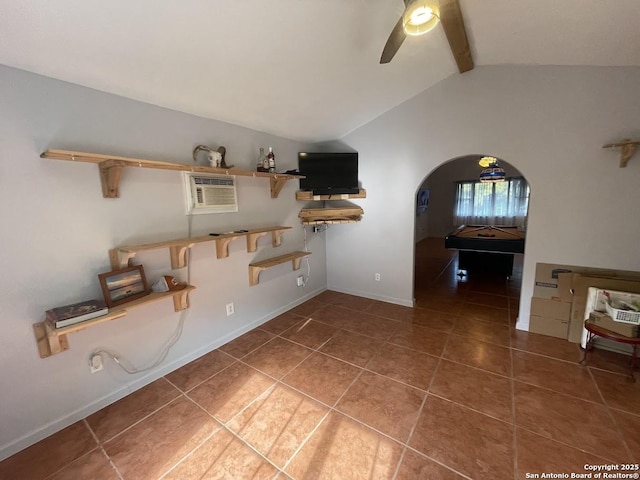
[0, 0, 640, 141]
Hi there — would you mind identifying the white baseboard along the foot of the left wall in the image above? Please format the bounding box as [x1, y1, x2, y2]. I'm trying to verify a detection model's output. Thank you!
[0, 287, 326, 461]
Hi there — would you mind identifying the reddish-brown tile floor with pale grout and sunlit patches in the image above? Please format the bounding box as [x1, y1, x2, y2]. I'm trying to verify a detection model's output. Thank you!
[0, 239, 640, 480]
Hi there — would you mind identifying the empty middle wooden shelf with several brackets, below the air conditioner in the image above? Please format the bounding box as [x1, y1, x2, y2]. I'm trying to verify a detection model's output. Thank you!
[109, 226, 292, 270]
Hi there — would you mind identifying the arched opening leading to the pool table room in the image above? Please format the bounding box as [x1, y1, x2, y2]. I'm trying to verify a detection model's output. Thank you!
[414, 155, 529, 328]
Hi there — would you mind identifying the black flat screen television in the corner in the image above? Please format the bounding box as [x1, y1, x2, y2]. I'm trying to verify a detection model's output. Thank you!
[298, 152, 359, 195]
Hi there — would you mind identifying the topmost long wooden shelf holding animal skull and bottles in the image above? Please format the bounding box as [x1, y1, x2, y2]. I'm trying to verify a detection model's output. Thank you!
[40, 149, 304, 198]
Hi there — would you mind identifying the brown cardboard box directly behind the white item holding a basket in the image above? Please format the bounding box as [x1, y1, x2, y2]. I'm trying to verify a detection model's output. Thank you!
[568, 272, 640, 343]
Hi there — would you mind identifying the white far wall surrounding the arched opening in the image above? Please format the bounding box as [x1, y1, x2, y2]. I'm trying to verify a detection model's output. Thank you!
[327, 66, 640, 318]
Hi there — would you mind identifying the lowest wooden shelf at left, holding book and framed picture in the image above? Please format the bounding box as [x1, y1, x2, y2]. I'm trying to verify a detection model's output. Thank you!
[33, 285, 196, 358]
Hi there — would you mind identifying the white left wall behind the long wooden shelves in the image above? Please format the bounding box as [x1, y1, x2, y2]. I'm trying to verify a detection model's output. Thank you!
[0, 67, 326, 459]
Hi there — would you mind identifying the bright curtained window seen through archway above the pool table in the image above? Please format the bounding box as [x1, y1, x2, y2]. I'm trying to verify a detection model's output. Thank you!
[454, 178, 529, 227]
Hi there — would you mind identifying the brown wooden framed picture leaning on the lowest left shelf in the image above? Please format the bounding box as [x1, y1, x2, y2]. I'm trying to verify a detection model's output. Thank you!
[98, 265, 151, 308]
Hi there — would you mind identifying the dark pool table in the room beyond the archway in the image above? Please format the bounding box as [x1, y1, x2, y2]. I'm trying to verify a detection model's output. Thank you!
[444, 225, 525, 277]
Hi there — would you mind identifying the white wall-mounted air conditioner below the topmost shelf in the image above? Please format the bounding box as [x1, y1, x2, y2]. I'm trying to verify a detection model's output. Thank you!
[184, 172, 238, 215]
